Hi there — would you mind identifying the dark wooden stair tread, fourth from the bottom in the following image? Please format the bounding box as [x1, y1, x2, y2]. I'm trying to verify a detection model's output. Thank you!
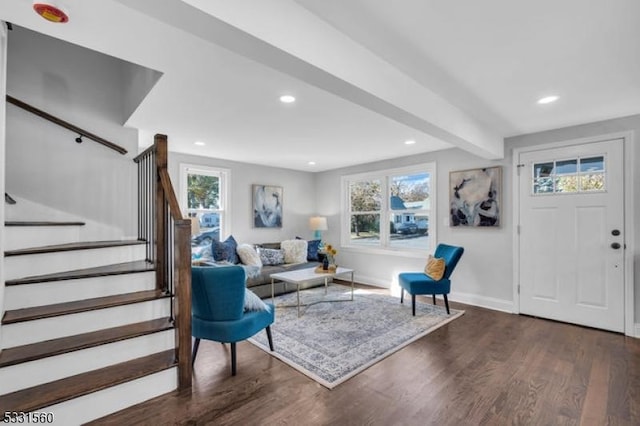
[5, 260, 155, 286]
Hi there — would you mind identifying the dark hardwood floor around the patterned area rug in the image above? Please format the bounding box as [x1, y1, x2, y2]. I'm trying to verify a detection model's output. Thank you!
[90, 290, 640, 426]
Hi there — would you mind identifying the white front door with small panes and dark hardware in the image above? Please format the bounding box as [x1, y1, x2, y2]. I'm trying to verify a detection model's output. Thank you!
[518, 139, 625, 332]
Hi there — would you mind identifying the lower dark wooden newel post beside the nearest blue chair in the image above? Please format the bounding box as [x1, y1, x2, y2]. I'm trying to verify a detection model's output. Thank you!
[174, 219, 191, 389]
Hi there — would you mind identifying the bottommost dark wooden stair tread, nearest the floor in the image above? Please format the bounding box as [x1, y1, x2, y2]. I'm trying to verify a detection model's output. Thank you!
[0, 349, 177, 413]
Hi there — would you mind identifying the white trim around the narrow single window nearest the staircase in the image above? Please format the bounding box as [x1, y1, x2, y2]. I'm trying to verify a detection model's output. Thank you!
[180, 163, 233, 241]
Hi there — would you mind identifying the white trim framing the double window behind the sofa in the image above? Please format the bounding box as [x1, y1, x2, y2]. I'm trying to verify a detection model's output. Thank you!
[340, 162, 438, 258]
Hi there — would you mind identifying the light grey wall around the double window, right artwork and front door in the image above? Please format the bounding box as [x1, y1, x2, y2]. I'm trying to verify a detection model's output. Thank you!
[316, 116, 640, 322]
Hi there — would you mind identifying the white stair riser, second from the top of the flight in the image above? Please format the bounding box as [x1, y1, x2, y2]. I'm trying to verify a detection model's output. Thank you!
[4, 244, 145, 280]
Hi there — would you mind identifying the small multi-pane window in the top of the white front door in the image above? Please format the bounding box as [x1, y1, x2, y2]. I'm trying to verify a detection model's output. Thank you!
[531, 156, 606, 195]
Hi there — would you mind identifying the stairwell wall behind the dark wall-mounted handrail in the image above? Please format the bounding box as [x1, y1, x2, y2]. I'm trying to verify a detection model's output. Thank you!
[6, 27, 138, 238]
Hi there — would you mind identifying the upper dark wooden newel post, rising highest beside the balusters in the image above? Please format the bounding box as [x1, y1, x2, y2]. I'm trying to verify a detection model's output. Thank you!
[154, 134, 168, 291]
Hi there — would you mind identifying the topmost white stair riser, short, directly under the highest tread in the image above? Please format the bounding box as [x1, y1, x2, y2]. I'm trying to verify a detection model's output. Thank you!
[4, 226, 80, 250]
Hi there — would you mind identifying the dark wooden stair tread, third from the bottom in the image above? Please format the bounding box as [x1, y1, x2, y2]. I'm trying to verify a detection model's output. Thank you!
[2, 290, 169, 325]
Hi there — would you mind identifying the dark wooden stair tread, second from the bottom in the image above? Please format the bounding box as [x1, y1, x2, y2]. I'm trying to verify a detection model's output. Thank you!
[0, 317, 174, 367]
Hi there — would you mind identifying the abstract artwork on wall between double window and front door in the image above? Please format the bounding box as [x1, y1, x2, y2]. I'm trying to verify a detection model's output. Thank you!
[449, 166, 502, 227]
